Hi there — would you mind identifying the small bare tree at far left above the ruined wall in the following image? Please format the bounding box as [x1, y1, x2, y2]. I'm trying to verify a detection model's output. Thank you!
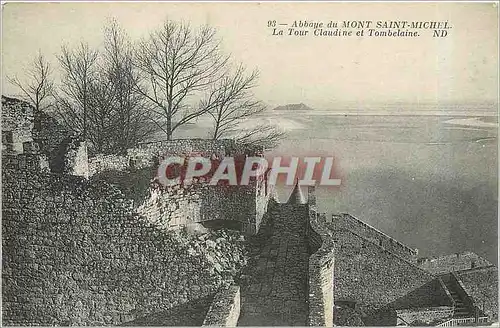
[8, 51, 54, 112]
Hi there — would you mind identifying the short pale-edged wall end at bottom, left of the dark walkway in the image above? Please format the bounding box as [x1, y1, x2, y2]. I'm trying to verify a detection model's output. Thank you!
[203, 286, 240, 327]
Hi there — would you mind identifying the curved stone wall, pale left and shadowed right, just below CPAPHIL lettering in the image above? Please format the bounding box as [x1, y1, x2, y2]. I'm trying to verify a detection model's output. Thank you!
[125, 178, 269, 234]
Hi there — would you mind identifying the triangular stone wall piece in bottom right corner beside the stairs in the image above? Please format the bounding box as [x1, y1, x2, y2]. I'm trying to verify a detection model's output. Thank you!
[455, 266, 498, 320]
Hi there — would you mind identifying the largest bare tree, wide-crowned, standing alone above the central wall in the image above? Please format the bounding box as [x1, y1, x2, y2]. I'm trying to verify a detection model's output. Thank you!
[136, 21, 228, 140]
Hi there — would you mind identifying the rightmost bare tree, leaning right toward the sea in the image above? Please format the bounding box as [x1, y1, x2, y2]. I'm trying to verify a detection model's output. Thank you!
[208, 65, 284, 148]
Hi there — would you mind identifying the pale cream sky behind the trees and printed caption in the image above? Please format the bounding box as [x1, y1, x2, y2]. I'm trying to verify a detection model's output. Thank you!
[2, 3, 498, 109]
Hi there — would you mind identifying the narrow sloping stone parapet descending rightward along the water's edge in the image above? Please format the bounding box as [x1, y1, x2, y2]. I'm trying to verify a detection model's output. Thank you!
[331, 214, 418, 260]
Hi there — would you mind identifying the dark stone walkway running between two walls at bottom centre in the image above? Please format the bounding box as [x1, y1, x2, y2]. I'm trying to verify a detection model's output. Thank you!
[238, 204, 308, 326]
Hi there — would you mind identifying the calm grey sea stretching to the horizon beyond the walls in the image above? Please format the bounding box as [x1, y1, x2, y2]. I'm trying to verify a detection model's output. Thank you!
[176, 105, 498, 264]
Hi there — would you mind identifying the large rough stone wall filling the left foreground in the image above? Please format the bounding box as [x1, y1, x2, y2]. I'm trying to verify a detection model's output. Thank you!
[2, 154, 248, 325]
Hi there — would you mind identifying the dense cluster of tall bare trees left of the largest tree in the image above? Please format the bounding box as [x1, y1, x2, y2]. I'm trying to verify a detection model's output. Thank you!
[55, 21, 155, 153]
